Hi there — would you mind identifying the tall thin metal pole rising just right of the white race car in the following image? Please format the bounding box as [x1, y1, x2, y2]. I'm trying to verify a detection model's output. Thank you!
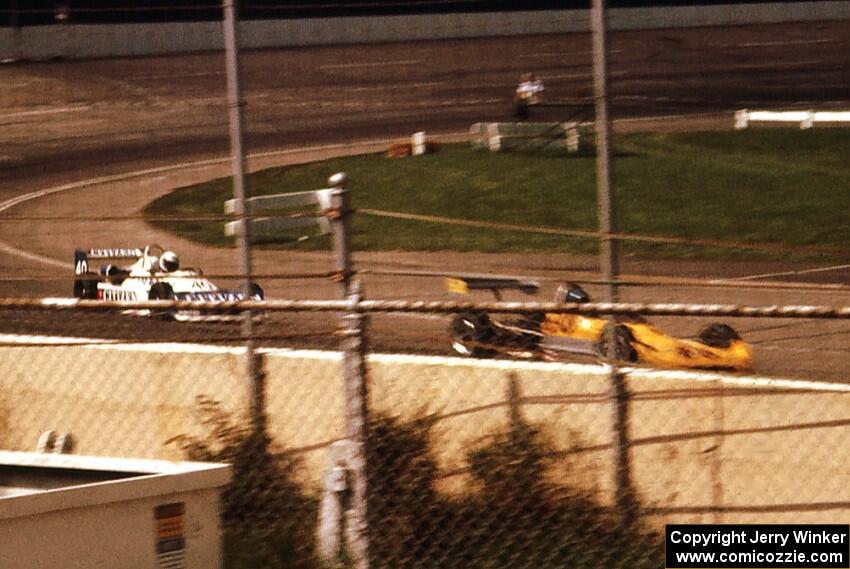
[223, 0, 265, 434]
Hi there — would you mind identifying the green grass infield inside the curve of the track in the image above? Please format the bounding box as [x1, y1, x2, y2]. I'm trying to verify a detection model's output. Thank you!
[145, 129, 850, 259]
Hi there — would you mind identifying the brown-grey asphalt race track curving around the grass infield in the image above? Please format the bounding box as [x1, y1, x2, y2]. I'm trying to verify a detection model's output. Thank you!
[0, 21, 850, 382]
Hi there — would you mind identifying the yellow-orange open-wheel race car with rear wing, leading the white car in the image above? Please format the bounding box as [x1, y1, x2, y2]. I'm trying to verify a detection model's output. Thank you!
[448, 277, 753, 370]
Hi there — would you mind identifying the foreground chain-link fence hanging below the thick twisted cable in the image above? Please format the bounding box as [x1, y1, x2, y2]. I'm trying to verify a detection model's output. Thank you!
[0, 299, 850, 567]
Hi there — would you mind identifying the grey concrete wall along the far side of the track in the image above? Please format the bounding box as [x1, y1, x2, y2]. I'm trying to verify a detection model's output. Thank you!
[0, 0, 850, 60]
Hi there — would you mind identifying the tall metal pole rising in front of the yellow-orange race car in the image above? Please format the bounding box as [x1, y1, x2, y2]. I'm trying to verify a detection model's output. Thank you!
[591, 0, 636, 525]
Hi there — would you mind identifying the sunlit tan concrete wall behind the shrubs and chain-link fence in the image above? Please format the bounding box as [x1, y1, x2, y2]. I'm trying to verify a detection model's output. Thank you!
[0, 338, 850, 523]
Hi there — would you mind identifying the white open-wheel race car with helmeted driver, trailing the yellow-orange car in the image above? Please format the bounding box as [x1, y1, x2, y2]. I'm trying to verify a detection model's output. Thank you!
[74, 245, 265, 322]
